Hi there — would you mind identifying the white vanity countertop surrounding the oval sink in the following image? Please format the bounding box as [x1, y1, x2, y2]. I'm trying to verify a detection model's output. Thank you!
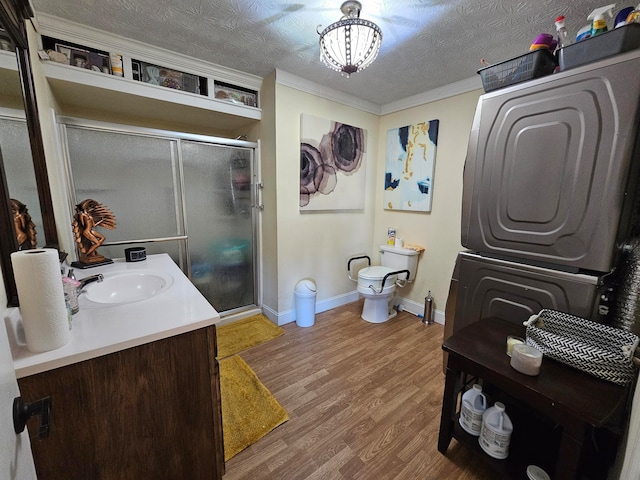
[5, 254, 220, 378]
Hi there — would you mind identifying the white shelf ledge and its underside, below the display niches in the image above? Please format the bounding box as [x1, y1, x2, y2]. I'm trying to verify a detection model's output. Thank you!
[42, 61, 262, 131]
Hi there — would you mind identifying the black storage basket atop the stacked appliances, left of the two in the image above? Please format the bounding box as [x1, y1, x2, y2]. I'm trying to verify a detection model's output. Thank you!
[478, 48, 558, 92]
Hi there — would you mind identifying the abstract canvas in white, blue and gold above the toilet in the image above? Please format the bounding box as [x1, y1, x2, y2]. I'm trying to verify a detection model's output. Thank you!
[384, 120, 440, 212]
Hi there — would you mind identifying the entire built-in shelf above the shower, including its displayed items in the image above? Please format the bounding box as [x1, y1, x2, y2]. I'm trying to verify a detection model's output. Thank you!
[33, 16, 262, 133]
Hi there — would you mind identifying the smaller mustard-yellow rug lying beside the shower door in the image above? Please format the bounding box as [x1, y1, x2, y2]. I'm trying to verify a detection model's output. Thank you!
[216, 314, 284, 358]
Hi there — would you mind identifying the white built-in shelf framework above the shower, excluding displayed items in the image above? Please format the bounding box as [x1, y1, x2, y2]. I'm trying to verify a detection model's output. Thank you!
[37, 13, 262, 135]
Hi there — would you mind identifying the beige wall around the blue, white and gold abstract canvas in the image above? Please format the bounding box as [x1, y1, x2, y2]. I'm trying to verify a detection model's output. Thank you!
[374, 90, 482, 321]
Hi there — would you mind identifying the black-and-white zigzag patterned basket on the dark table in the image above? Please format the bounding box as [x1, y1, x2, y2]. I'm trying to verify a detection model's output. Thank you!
[524, 310, 639, 385]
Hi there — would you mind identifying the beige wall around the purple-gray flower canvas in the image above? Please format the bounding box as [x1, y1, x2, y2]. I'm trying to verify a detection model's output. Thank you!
[272, 79, 379, 321]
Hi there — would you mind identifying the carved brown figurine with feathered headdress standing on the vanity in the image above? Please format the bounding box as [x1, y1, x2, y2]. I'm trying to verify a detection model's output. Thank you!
[72, 198, 116, 268]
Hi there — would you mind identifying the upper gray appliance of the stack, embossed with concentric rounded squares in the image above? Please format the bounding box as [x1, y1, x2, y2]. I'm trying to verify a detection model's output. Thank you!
[462, 51, 640, 272]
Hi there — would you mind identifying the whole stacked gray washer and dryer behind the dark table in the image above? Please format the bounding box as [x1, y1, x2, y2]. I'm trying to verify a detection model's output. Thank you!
[445, 50, 640, 344]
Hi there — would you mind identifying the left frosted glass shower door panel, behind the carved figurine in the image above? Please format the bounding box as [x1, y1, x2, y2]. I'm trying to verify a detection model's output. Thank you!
[66, 125, 186, 265]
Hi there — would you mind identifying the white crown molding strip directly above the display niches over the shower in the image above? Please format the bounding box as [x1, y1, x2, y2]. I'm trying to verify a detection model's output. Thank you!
[35, 12, 262, 91]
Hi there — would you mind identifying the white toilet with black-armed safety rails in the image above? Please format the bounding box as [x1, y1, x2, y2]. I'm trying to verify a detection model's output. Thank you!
[347, 245, 420, 323]
